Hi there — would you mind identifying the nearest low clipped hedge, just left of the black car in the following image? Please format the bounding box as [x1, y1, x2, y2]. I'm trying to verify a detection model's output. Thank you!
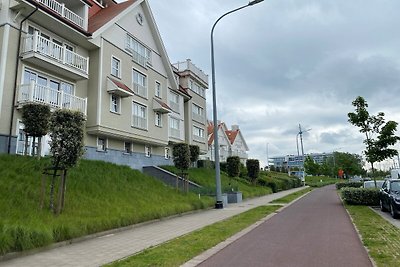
[341, 187, 379, 206]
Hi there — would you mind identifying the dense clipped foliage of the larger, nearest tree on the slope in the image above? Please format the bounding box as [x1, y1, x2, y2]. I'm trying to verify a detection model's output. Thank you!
[50, 109, 85, 169]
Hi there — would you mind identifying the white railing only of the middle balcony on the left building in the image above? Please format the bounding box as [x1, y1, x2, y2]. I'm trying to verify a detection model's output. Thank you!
[23, 32, 89, 74]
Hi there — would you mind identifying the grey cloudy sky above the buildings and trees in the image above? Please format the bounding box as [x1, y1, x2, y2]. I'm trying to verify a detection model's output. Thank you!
[149, 0, 400, 170]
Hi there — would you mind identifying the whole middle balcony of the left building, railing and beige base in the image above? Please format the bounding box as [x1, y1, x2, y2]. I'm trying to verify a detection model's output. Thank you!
[22, 32, 89, 80]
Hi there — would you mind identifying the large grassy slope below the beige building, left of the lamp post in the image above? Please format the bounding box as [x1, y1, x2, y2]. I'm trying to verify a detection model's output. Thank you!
[0, 155, 214, 254]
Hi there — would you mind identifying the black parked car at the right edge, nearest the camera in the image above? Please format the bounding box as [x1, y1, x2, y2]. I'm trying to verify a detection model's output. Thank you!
[379, 179, 400, 218]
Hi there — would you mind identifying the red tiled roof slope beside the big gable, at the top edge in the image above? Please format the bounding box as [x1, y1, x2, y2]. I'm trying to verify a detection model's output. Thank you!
[88, 0, 137, 33]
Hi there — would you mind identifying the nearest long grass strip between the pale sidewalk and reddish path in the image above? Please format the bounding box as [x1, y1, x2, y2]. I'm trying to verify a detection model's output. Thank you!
[107, 205, 280, 267]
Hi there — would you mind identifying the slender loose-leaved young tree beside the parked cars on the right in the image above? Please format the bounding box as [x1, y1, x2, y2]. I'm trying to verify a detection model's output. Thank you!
[348, 96, 400, 186]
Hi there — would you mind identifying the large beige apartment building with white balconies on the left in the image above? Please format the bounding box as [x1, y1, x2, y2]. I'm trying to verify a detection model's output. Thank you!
[0, 0, 208, 169]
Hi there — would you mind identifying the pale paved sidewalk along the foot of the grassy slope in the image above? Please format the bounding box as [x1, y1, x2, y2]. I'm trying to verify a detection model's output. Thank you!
[0, 187, 304, 267]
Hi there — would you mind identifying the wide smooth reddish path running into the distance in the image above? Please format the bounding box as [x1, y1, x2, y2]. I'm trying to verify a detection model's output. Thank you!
[195, 186, 372, 267]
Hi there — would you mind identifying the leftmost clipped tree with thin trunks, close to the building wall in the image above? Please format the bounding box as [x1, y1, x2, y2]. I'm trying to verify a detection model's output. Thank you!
[22, 104, 51, 158]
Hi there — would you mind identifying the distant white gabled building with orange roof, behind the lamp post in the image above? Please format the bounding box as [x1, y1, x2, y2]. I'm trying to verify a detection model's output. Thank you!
[205, 121, 249, 164]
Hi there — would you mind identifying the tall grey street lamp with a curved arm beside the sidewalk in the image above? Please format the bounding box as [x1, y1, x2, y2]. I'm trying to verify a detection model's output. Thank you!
[211, 0, 264, 209]
